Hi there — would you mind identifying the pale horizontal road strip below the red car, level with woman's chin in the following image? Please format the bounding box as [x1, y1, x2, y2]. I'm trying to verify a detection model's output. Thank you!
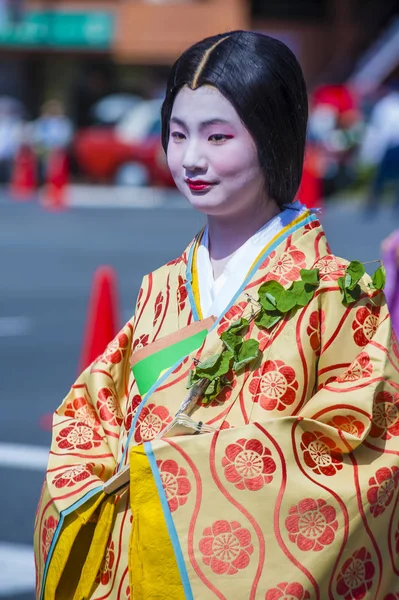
[66, 185, 190, 210]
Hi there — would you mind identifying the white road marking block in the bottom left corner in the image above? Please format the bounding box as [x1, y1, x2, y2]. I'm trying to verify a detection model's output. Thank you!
[0, 542, 35, 598]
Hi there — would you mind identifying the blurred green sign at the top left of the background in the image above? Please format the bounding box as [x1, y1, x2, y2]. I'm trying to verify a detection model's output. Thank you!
[0, 11, 114, 50]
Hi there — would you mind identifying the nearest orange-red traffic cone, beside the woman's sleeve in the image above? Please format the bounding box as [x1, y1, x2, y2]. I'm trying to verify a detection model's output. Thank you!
[79, 266, 119, 373]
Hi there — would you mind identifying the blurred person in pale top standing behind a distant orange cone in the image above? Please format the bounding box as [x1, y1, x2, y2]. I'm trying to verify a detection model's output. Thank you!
[31, 98, 73, 183]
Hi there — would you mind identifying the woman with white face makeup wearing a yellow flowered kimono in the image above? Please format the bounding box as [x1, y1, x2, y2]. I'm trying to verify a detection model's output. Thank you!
[35, 31, 399, 600]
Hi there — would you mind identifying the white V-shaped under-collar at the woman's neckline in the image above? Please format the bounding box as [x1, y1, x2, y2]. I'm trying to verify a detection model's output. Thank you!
[196, 200, 307, 318]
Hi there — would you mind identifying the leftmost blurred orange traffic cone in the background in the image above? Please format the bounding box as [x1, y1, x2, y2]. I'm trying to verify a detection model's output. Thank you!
[9, 144, 37, 200]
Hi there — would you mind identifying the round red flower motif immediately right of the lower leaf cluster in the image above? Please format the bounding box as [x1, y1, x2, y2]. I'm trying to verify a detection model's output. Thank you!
[249, 360, 298, 410]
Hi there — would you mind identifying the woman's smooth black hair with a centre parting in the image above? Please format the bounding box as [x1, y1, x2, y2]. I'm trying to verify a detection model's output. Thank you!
[162, 31, 308, 207]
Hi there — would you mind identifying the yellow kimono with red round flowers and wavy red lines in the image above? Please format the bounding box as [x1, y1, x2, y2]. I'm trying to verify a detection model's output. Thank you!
[35, 212, 399, 600]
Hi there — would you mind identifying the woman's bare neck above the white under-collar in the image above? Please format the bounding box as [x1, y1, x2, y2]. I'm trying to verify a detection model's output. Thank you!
[208, 200, 280, 270]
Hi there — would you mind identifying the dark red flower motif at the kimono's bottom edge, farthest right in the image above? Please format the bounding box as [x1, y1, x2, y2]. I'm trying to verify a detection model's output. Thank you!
[337, 548, 375, 600]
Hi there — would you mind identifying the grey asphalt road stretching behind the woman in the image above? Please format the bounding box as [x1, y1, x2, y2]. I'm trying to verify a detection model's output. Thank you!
[0, 190, 399, 600]
